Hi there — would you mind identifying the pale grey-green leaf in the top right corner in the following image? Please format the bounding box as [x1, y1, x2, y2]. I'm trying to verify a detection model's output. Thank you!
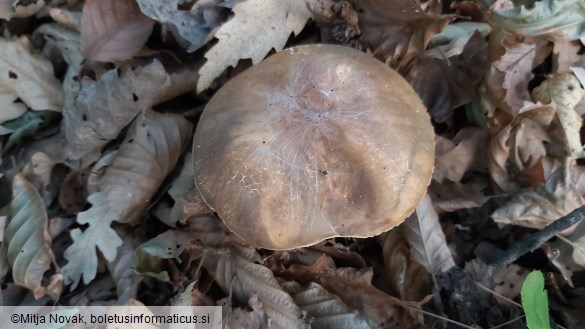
[490, 0, 585, 40]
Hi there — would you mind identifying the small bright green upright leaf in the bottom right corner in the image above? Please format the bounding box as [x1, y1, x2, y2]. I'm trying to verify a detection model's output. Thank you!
[521, 271, 550, 329]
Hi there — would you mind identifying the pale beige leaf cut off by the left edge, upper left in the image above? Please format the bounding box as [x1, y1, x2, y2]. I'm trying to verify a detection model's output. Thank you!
[0, 37, 63, 114]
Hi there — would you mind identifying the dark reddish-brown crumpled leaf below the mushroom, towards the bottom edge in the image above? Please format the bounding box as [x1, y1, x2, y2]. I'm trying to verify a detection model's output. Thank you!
[274, 256, 420, 329]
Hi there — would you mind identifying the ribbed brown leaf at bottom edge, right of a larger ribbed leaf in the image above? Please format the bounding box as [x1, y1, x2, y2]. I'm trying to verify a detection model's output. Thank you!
[282, 281, 380, 329]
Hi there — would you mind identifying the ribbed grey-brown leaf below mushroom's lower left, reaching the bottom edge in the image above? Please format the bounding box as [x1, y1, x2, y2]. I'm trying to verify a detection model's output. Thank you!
[203, 246, 310, 329]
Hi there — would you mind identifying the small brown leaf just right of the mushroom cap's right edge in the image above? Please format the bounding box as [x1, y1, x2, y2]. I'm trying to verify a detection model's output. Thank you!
[433, 127, 489, 182]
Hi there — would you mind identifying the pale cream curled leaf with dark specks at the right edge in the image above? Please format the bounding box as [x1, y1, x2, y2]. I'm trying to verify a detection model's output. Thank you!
[532, 72, 585, 157]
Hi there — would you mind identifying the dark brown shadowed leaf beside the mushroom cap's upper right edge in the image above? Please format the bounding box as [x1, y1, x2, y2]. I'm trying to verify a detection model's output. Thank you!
[405, 31, 489, 122]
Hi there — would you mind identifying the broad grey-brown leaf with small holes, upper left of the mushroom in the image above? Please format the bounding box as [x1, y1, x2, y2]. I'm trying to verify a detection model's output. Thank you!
[61, 60, 199, 159]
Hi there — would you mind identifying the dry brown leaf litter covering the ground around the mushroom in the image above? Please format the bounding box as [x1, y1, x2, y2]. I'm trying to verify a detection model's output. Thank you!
[0, 0, 585, 328]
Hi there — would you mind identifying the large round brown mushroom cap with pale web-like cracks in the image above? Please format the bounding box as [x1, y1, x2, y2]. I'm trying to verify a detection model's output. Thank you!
[193, 44, 435, 250]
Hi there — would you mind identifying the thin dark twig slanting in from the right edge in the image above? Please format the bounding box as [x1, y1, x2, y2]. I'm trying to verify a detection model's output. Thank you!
[488, 206, 585, 276]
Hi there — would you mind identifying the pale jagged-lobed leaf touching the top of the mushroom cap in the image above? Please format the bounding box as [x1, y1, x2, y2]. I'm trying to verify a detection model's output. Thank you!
[197, 0, 316, 92]
